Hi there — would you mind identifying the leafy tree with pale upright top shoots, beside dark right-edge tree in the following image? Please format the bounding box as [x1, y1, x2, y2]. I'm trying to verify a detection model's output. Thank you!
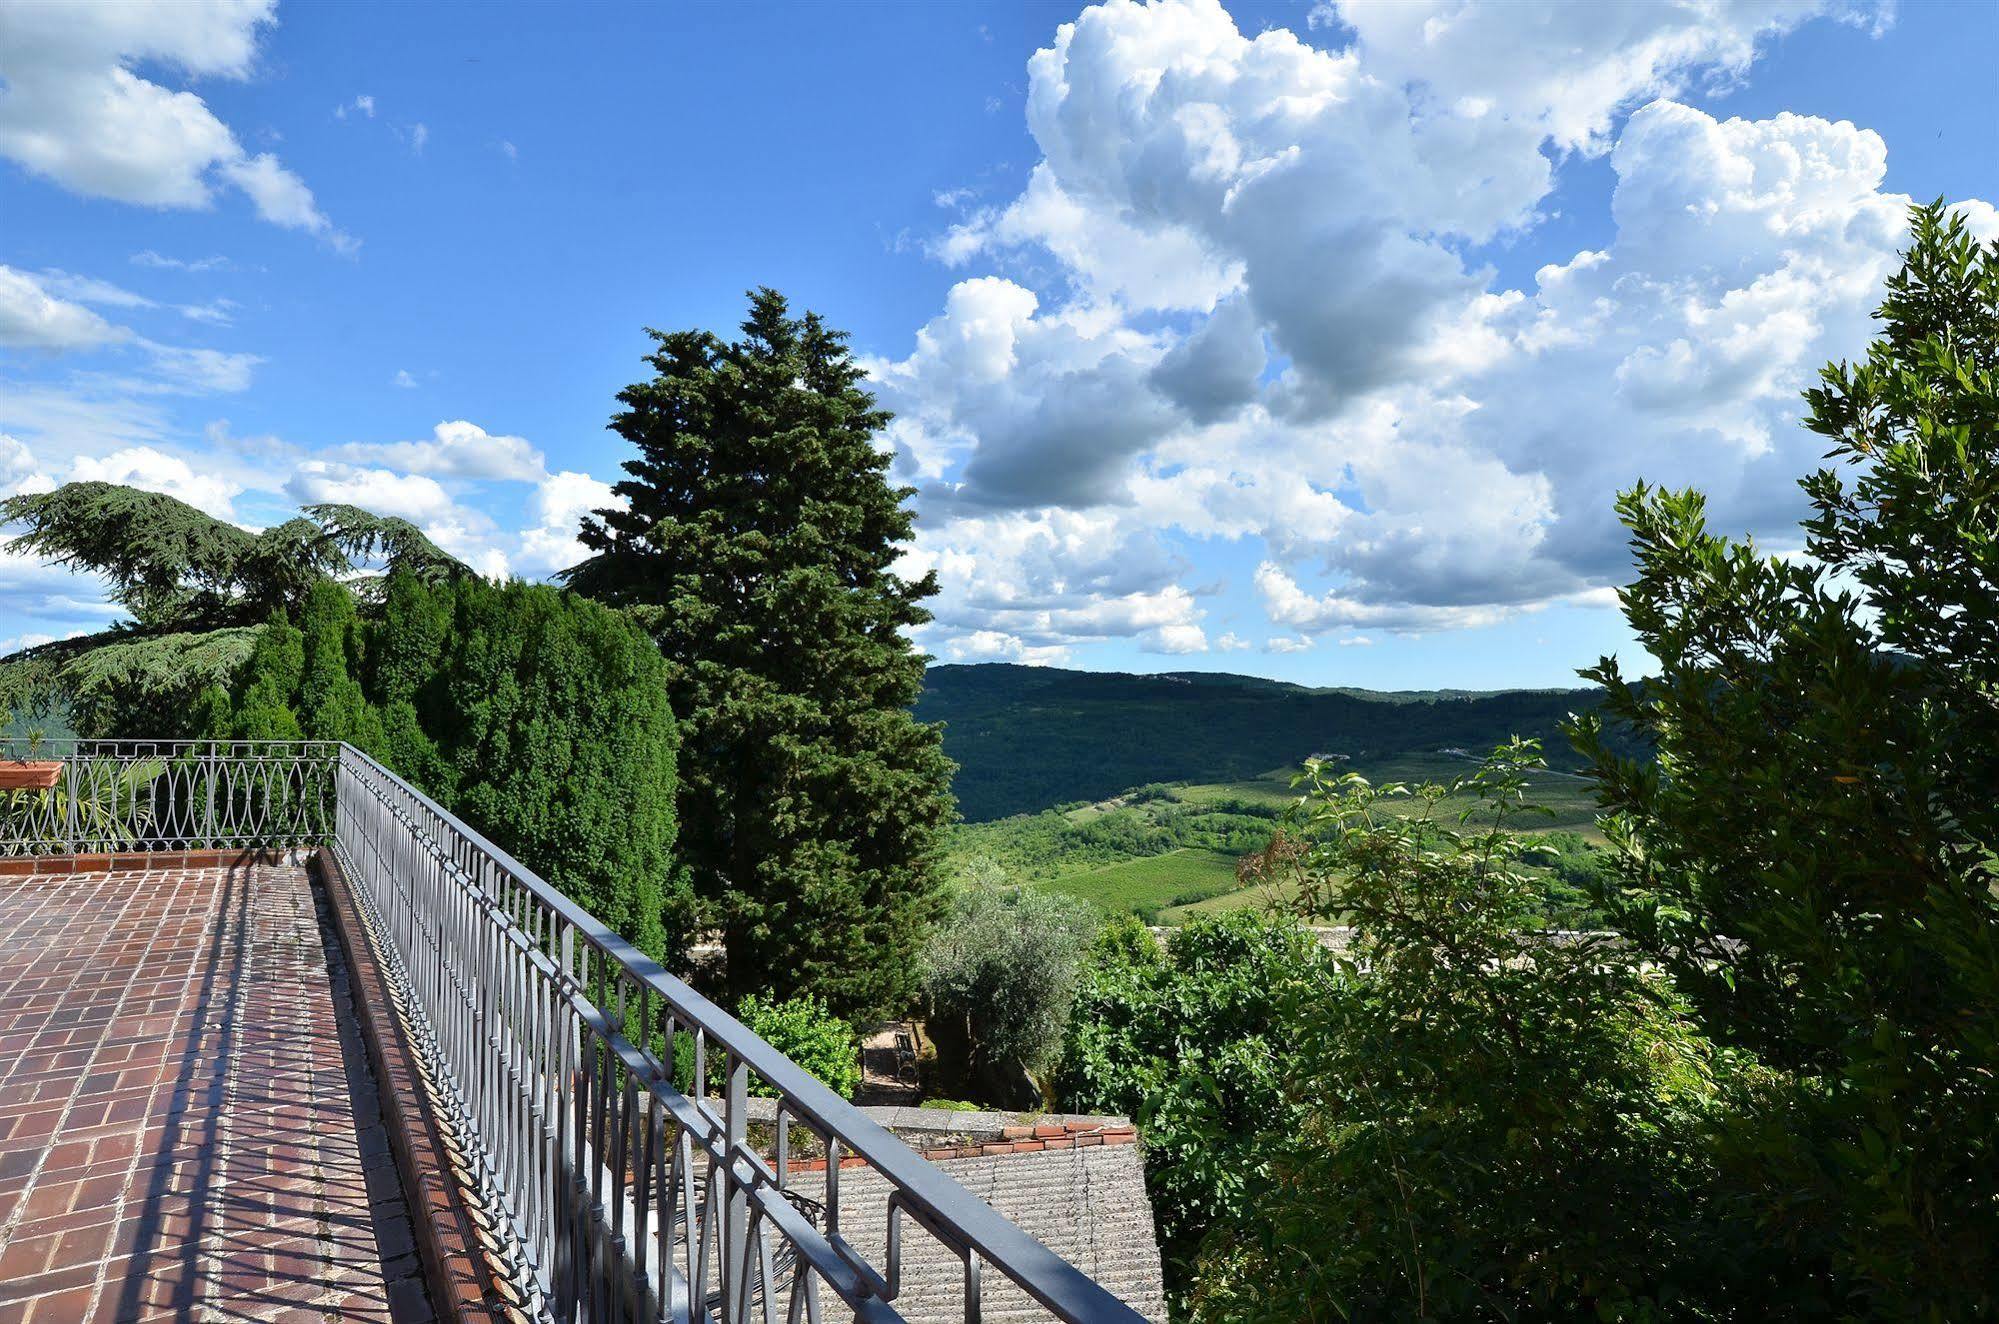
[1195, 744, 1737, 1320]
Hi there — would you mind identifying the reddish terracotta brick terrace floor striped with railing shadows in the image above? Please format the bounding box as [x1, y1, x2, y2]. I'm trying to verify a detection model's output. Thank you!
[0, 864, 430, 1324]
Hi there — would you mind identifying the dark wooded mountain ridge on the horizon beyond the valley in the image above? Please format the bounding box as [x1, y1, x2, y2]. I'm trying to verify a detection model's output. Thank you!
[916, 662, 1603, 822]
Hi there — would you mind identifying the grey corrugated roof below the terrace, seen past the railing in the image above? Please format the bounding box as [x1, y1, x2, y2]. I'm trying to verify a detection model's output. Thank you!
[840, 1144, 1165, 1324]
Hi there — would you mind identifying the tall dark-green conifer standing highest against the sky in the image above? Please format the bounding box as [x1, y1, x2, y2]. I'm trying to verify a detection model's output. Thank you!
[568, 288, 952, 1016]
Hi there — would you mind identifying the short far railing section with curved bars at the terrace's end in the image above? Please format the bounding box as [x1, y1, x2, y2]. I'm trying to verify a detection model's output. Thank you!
[0, 740, 340, 856]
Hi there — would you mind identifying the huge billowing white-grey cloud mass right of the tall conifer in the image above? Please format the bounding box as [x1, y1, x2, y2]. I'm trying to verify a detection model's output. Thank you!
[872, 0, 1999, 660]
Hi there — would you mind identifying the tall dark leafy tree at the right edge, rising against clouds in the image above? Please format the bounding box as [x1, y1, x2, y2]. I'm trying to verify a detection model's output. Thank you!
[1577, 206, 1999, 1318]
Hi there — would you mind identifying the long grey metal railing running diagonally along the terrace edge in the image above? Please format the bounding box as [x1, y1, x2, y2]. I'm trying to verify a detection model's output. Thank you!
[0, 742, 1139, 1324]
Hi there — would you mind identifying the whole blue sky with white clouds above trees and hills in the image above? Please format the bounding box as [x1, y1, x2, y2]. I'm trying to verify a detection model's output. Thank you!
[0, 0, 1999, 688]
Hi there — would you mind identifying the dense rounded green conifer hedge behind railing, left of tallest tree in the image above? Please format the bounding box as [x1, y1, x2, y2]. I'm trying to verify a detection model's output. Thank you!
[204, 574, 690, 960]
